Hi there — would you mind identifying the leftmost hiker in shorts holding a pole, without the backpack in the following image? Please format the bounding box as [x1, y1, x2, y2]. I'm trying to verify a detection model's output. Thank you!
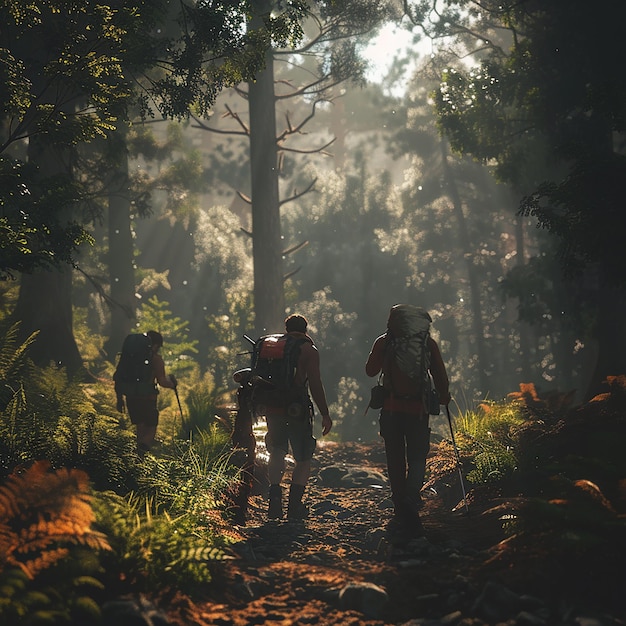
[116, 330, 177, 456]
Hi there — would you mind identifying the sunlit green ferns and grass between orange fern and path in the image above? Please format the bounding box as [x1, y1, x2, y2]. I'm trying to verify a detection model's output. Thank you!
[95, 429, 235, 595]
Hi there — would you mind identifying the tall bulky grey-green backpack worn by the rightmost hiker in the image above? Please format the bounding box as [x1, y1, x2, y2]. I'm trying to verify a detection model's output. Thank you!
[387, 304, 432, 396]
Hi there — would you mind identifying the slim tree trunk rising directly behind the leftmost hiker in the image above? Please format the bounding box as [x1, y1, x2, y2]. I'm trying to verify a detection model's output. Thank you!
[104, 128, 136, 363]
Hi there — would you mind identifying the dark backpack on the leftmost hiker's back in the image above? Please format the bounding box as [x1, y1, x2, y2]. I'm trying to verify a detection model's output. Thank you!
[113, 333, 157, 396]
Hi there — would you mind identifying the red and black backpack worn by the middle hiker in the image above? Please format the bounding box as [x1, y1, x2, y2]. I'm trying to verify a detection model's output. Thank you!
[250, 333, 308, 406]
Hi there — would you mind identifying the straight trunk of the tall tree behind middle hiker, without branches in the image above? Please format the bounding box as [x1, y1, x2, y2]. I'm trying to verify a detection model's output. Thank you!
[249, 0, 285, 334]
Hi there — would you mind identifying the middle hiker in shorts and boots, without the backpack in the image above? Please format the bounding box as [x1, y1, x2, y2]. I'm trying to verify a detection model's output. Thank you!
[264, 314, 333, 520]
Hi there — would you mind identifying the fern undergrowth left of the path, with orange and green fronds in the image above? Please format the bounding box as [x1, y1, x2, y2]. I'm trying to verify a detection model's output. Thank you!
[0, 327, 246, 626]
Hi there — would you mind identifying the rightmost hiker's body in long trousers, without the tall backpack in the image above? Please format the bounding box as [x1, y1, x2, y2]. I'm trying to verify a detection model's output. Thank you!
[365, 305, 450, 533]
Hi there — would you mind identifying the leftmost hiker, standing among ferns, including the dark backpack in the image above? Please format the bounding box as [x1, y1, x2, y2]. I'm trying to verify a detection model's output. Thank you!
[113, 330, 178, 457]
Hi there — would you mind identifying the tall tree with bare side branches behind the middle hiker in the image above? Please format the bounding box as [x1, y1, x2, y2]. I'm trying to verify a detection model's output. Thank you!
[197, 0, 390, 332]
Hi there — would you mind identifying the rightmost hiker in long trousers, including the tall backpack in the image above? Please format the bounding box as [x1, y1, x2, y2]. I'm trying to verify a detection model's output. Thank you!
[365, 304, 450, 534]
